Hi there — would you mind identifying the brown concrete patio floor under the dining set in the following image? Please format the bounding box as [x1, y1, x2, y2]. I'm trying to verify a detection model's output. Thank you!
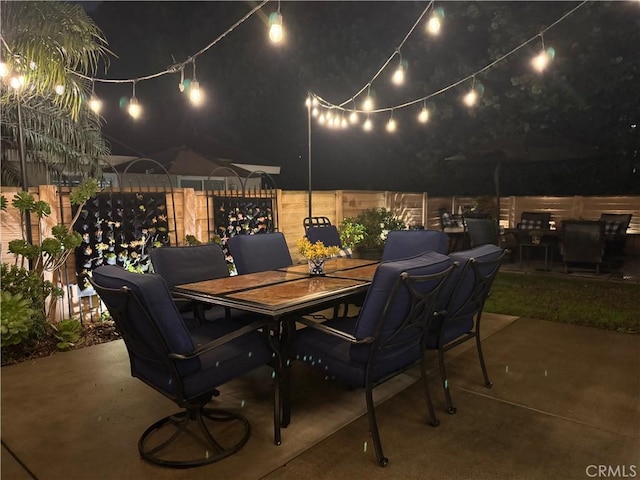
[1, 314, 640, 480]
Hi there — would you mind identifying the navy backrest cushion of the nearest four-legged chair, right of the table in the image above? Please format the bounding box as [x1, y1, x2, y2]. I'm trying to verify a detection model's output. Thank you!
[350, 252, 453, 362]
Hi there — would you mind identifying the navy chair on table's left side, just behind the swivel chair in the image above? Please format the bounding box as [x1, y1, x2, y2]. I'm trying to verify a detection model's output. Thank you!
[150, 243, 230, 323]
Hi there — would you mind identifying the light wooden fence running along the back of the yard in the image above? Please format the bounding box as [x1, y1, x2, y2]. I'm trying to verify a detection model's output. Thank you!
[0, 185, 640, 320]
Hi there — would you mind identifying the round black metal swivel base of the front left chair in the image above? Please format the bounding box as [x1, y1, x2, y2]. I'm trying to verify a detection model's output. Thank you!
[138, 407, 251, 468]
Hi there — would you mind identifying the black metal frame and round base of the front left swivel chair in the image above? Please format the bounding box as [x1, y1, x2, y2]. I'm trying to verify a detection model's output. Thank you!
[91, 281, 282, 468]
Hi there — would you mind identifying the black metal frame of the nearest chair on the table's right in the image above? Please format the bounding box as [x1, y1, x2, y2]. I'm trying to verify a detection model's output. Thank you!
[284, 265, 455, 467]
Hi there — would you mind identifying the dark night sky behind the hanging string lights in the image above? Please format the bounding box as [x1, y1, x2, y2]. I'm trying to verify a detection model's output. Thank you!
[88, 1, 638, 191]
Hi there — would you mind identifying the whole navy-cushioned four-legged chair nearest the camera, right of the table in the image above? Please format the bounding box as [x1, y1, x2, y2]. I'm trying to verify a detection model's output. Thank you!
[285, 252, 453, 466]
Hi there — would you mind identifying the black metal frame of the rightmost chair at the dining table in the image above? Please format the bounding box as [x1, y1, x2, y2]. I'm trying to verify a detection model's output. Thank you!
[438, 250, 508, 414]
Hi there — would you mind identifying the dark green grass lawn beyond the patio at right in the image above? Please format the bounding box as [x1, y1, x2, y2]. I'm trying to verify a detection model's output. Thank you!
[484, 272, 640, 333]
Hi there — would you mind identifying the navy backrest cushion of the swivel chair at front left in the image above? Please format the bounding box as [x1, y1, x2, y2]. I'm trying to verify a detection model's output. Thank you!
[92, 265, 198, 366]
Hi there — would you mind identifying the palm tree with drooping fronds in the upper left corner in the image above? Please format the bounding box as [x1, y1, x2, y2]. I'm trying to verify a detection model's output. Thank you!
[0, 1, 111, 185]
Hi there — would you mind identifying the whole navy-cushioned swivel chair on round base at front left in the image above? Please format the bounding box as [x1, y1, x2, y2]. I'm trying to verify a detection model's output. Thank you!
[92, 266, 281, 468]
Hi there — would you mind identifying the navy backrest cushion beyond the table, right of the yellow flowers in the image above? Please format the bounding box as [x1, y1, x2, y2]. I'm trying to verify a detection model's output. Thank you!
[382, 230, 449, 261]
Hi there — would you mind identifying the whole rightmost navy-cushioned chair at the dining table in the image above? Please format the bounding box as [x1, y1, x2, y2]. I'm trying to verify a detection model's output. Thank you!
[426, 244, 506, 414]
